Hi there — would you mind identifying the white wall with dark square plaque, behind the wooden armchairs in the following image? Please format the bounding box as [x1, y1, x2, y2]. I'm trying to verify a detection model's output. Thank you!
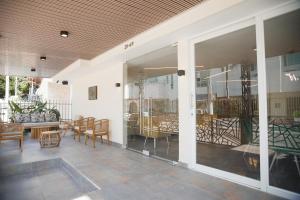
[71, 62, 123, 144]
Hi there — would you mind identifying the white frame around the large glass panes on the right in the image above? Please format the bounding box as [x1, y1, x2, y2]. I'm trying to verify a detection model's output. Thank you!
[188, 0, 300, 199]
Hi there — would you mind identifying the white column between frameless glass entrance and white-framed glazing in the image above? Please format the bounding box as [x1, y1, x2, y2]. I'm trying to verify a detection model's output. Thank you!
[177, 40, 196, 167]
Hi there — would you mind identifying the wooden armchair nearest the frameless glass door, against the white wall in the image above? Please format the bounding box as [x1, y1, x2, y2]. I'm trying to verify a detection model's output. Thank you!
[84, 119, 110, 148]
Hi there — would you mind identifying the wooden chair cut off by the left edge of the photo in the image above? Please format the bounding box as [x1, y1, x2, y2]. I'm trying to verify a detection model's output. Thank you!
[0, 123, 24, 152]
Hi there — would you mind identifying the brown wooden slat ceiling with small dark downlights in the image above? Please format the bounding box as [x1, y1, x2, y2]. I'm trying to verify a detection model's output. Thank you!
[0, 0, 203, 77]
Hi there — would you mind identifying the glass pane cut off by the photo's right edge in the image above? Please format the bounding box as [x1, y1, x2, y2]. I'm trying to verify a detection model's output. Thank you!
[265, 10, 300, 193]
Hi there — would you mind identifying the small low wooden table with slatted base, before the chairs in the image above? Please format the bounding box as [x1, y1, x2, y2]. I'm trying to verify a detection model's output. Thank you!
[40, 131, 61, 148]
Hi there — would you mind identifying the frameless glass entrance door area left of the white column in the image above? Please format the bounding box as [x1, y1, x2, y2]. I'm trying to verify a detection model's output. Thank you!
[125, 47, 179, 161]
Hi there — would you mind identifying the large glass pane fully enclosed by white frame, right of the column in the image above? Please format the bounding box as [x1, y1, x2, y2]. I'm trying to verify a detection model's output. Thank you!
[195, 26, 260, 179]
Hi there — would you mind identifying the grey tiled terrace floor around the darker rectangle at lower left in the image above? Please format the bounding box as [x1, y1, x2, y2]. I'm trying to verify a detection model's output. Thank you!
[0, 133, 280, 200]
